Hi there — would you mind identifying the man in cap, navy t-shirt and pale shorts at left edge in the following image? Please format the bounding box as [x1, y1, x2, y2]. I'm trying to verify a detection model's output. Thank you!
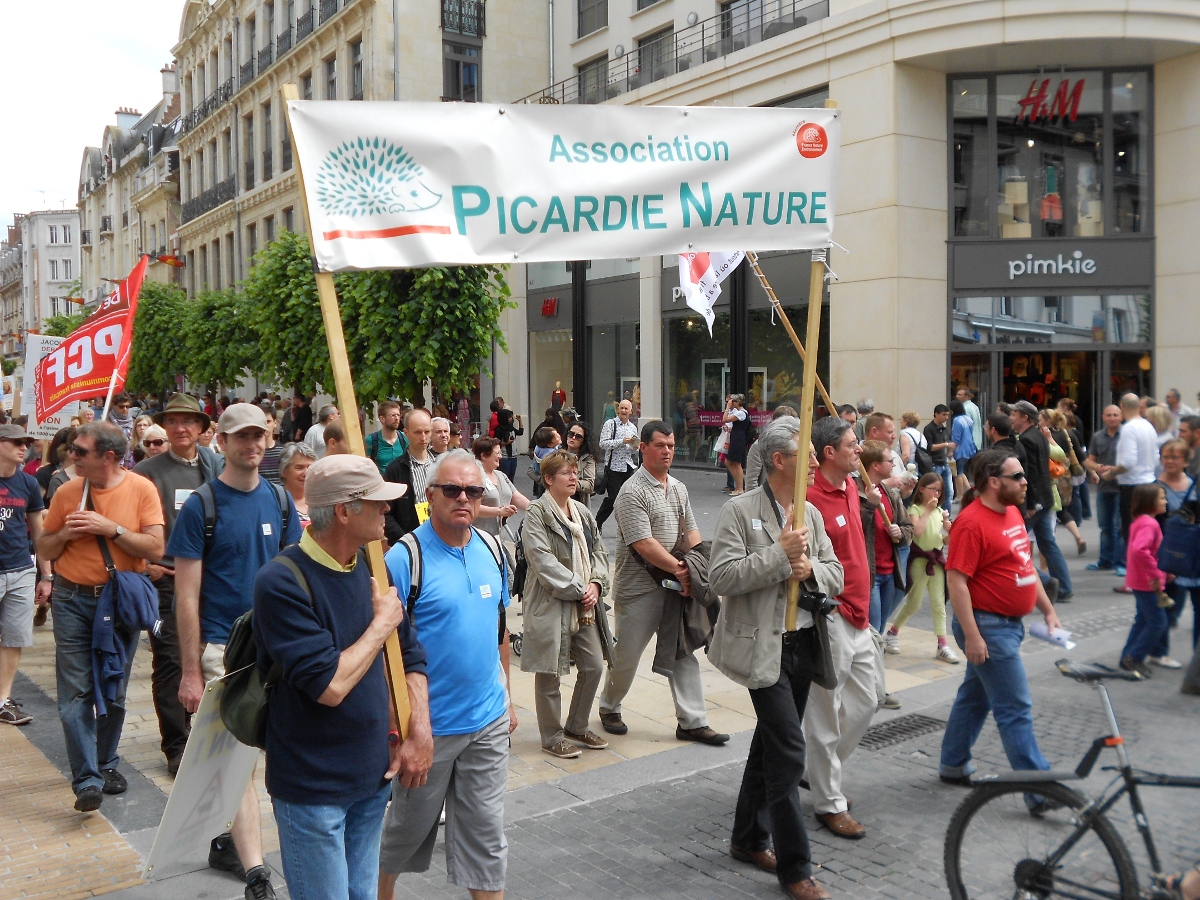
[0, 425, 53, 725]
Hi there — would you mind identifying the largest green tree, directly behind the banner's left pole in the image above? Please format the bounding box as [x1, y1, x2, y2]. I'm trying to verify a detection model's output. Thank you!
[244, 233, 512, 402]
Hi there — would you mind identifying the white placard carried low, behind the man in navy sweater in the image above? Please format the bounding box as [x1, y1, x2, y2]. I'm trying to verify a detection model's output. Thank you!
[142, 678, 258, 878]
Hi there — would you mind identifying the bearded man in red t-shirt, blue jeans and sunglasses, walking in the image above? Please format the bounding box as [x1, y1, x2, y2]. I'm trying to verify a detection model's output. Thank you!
[938, 450, 1061, 787]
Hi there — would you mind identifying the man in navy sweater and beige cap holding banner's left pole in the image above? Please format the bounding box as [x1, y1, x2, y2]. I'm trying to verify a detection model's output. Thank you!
[254, 455, 433, 900]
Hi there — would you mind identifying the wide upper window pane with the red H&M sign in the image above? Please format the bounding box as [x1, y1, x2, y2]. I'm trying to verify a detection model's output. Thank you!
[996, 72, 1104, 238]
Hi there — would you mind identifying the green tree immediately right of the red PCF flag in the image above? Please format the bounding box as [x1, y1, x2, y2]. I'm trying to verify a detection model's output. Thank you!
[125, 281, 194, 394]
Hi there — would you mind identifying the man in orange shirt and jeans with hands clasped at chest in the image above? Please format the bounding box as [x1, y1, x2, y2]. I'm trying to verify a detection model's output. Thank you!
[37, 422, 163, 812]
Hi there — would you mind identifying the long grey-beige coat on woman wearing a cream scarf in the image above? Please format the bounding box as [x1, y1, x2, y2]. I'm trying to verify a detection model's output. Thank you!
[521, 493, 613, 676]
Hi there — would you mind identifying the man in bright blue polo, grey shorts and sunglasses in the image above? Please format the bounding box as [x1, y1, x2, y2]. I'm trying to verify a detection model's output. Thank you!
[379, 450, 511, 900]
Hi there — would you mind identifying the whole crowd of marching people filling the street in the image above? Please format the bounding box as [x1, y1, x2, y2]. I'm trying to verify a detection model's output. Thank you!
[0, 388, 1200, 900]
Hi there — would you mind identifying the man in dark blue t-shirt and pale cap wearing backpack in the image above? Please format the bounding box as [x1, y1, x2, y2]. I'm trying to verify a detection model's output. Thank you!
[167, 403, 300, 900]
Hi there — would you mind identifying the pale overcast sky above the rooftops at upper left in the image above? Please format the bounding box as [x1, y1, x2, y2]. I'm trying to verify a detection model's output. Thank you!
[0, 0, 184, 227]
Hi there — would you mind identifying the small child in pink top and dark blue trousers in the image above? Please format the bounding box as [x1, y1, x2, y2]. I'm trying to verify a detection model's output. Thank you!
[1121, 482, 1171, 678]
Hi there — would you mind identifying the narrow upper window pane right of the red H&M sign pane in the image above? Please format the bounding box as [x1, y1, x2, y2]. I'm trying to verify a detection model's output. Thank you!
[1112, 72, 1150, 233]
